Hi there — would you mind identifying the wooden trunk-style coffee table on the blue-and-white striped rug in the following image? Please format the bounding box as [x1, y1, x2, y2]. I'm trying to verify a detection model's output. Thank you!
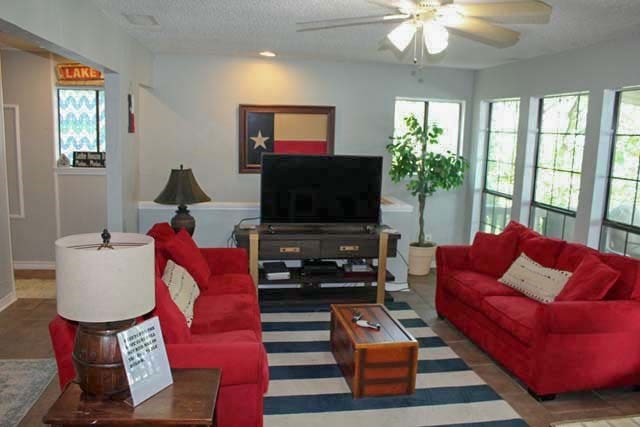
[331, 304, 418, 399]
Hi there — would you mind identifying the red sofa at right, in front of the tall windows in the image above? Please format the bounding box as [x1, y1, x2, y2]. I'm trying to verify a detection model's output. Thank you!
[436, 222, 640, 399]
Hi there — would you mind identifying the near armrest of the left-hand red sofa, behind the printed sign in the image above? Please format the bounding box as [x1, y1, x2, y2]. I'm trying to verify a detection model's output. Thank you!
[166, 342, 269, 387]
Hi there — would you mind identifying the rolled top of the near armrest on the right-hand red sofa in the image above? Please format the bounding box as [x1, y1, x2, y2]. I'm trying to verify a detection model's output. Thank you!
[542, 300, 640, 334]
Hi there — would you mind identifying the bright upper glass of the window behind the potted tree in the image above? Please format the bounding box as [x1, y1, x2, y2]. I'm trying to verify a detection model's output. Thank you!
[394, 99, 462, 154]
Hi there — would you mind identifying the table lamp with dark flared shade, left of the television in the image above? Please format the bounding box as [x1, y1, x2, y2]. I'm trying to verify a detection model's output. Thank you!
[154, 165, 211, 236]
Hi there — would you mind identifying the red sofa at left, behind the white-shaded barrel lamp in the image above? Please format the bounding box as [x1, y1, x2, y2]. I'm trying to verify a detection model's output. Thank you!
[49, 224, 269, 427]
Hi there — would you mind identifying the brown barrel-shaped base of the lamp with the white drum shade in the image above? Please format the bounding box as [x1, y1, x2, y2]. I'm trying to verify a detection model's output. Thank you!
[73, 319, 135, 400]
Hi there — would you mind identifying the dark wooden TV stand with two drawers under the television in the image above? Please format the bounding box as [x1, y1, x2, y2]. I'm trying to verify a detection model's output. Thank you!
[235, 224, 401, 304]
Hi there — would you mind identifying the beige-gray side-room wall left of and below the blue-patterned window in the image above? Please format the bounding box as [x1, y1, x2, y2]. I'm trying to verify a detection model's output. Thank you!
[0, 51, 107, 267]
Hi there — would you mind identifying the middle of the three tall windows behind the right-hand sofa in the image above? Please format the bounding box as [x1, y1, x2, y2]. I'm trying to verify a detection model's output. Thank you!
[531, 94, 589, 240]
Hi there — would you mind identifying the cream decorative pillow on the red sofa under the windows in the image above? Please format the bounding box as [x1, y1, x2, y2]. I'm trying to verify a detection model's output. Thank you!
[498, 253, 571, 303]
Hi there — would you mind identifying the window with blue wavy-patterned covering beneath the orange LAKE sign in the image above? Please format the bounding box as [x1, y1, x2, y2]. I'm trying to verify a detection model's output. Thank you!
[58, 88, 106, 162]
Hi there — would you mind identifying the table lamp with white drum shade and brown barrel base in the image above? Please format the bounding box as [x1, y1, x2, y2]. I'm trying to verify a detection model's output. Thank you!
[55, 230, 155, 400]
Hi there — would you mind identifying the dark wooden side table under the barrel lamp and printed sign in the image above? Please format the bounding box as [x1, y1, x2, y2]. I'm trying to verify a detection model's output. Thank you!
[43, 369, 221, 427]
